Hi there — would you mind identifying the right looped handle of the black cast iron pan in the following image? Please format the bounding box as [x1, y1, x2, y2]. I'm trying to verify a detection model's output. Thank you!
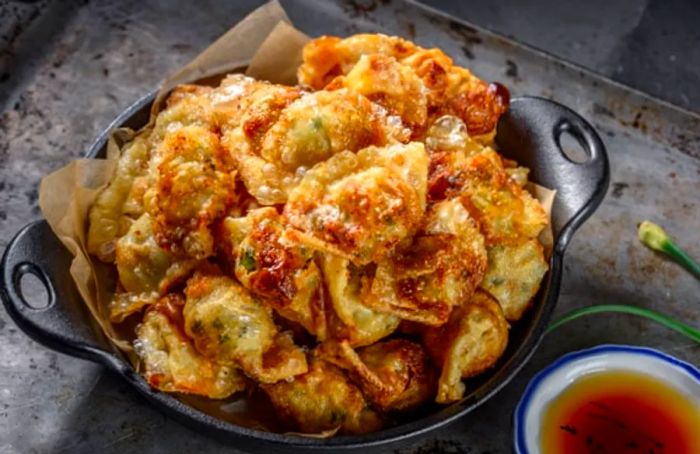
[496, 96, 610, 253]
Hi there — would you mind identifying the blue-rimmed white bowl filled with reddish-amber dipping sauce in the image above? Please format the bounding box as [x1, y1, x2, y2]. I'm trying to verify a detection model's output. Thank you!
[514, 345, 700, 454]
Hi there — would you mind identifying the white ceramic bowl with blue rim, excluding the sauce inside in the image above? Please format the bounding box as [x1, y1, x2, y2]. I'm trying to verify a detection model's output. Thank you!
[513, 345, 700, 454]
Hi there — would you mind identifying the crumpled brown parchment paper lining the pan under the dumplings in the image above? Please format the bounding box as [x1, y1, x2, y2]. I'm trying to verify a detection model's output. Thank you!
[39, 0, 554, 426]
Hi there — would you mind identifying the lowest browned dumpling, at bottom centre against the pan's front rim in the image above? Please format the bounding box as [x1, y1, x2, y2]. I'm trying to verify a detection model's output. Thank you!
[262, 358, 382, 434]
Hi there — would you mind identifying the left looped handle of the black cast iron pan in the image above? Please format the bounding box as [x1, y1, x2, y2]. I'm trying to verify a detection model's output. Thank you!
[0, 221, 125, 371]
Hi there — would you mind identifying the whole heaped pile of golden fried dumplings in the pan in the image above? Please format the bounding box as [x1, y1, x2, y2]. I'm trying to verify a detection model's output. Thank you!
[88, 34, 547, 434]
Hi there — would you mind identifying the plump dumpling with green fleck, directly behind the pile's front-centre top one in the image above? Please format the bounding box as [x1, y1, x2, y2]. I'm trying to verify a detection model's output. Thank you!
[224, 86, 408, 205]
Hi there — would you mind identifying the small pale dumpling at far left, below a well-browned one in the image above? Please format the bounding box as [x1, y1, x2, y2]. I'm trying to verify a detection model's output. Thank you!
[115, 214, 196, 295]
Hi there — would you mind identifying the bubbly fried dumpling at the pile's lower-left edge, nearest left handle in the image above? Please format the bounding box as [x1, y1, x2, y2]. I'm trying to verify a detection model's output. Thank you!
[134, 304, 246, 399]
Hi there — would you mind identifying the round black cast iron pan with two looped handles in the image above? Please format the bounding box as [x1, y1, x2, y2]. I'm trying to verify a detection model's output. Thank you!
[0, 94, 609, 452]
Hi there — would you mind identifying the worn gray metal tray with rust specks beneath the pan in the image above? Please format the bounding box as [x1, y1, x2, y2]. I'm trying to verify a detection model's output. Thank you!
[0, 0, 700, 454]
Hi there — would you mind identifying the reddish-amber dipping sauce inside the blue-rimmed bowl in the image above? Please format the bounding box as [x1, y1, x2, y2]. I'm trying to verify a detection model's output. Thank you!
[540, 371, 700, 454]
